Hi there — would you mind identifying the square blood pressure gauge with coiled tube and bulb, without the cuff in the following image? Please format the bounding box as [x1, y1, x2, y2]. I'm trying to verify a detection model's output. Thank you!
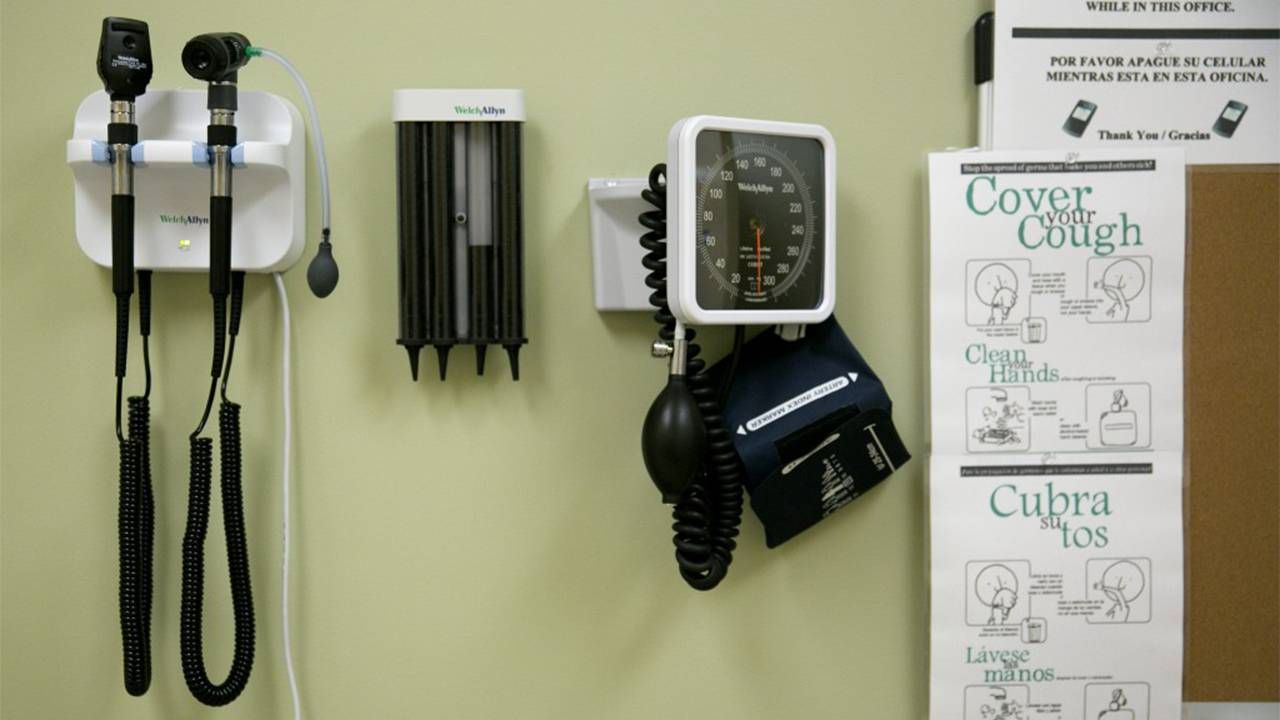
[639, 115, 836, 591]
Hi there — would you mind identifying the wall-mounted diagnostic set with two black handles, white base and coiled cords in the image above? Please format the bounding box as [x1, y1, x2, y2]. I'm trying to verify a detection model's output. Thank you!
[74, 18, 338, 706]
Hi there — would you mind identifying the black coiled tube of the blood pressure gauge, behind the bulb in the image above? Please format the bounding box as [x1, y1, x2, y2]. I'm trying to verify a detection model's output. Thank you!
[640, 164, 744, 591]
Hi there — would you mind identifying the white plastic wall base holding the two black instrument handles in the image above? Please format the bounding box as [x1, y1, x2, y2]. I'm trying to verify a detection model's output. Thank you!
[67, 90, 306, 273]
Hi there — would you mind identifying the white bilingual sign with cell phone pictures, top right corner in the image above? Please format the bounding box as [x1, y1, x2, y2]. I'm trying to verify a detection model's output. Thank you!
[992, 0, 1280, 164]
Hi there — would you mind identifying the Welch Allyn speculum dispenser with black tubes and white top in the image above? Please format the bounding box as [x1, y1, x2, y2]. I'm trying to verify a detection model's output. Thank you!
[392, 90, 529, 380]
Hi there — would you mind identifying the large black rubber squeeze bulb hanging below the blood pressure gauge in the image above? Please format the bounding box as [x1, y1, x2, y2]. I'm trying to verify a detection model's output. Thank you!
[640, 375, 707, 503]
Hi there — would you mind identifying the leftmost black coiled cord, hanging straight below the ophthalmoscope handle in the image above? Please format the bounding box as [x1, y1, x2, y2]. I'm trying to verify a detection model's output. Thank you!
[115, 270, 155, 696]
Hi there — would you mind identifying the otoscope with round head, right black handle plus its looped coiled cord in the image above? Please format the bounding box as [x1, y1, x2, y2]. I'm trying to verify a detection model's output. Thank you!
[179, 32, 253, 706]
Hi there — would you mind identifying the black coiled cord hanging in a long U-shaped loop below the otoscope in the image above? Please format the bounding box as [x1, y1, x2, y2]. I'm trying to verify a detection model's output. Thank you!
[179, 273, 253, 706]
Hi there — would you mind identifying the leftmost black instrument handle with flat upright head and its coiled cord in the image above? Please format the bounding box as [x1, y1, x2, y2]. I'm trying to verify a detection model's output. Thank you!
[97, 18, 155, 696]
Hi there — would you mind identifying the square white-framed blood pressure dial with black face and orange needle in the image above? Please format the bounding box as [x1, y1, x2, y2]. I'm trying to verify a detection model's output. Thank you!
[667, 115, 836, 325]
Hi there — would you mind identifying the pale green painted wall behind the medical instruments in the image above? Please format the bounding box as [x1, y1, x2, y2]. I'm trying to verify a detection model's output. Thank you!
[0, 0, 980, 720]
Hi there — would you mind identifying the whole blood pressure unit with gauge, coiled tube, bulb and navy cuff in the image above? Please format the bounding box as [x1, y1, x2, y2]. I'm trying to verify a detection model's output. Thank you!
[640, 115, 908, 589]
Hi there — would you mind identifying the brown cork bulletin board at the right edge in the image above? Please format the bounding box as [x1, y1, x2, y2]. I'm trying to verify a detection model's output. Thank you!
[1184, 165, 1280, 702]
